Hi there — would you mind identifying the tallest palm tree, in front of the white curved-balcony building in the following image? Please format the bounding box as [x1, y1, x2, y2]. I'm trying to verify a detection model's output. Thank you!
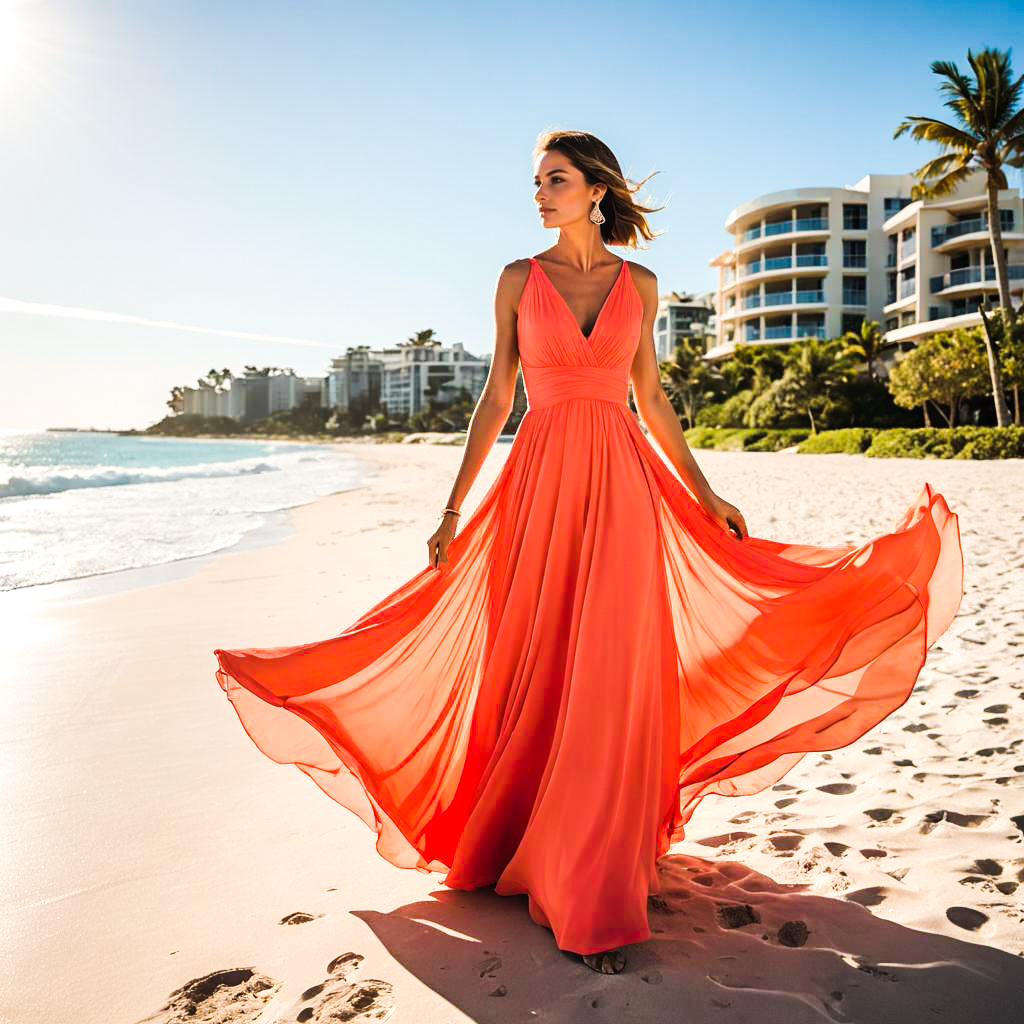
[893, 48, 1024, 427]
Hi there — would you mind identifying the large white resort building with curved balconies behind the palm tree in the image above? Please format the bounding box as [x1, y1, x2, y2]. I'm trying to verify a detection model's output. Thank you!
[707, 171, 1024, 370]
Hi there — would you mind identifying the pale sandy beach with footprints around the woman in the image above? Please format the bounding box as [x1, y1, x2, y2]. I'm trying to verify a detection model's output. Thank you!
[0, 442, 1024, 1024]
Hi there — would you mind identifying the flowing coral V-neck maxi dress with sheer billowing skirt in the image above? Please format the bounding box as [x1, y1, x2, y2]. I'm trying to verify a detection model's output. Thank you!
[215, 251, 964, 953]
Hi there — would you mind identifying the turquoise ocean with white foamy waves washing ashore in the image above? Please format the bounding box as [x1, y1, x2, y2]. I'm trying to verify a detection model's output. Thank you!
[0, 430, 362, 591]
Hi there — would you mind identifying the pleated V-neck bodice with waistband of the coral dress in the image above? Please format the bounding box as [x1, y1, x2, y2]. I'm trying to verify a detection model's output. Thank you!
[517, 257, 643, 410]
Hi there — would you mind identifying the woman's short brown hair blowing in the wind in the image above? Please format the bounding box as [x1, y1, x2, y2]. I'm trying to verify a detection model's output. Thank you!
[534, 131, 665, 249]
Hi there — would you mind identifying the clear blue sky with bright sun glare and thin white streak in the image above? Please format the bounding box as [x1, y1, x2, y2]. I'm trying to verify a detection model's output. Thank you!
[0, 0, 1024, 428]
